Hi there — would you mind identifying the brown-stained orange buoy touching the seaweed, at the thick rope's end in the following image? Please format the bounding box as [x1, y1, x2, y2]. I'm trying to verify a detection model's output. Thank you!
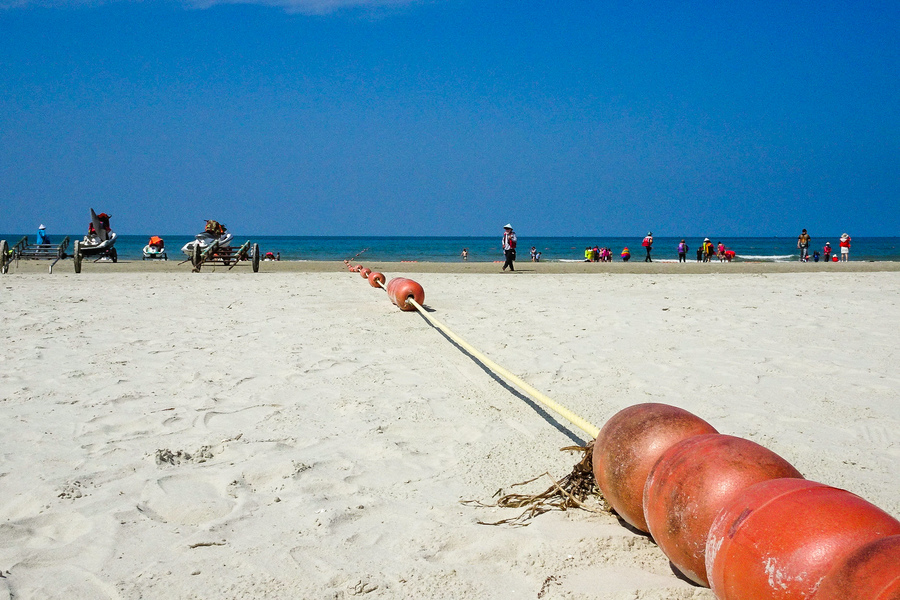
[592, 403, 718, 531]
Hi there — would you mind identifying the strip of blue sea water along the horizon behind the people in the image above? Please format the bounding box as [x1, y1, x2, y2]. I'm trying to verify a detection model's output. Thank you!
[0, 232, 900, 262]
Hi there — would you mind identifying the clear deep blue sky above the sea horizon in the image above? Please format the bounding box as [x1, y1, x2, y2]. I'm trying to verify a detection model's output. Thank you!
[0, 0, 900, 236]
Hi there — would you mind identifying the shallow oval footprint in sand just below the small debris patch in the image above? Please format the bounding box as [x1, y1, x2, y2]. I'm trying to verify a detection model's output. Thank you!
[137, 474, 236, 525]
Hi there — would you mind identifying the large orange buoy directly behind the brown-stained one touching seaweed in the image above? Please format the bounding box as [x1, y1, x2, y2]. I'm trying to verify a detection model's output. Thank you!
[644, 433, 803, 586]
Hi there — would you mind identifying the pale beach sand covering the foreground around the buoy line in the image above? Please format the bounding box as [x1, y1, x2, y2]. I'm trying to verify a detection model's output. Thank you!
[0, 263, 900, 600]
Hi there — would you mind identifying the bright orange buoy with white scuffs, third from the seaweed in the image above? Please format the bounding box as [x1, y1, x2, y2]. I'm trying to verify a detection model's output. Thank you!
[706, 479, 900, 600]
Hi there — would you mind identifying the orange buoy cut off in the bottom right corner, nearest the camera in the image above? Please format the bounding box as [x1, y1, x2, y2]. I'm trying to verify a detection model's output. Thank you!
[813, 535, 900, 600]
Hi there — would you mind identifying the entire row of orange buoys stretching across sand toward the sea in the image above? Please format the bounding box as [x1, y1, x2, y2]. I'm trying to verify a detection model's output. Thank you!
[344, 261, 900, 600]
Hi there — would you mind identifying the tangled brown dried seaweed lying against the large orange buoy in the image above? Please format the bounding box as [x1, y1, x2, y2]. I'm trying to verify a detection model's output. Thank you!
[462, 441, 609, 527]
